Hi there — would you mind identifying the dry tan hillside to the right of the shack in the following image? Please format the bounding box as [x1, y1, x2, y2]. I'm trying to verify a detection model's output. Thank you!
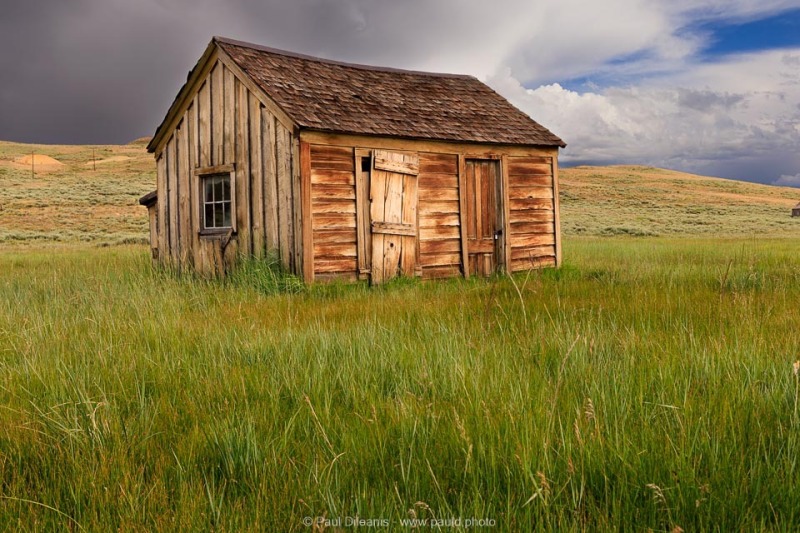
[559, 166, 800, 237]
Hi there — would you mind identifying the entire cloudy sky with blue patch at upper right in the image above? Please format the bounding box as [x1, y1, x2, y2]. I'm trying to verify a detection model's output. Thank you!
[0, 0, 800, 187]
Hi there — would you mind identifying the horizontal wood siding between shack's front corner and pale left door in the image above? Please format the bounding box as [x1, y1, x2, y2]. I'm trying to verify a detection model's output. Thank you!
[311, 145, 358, 279]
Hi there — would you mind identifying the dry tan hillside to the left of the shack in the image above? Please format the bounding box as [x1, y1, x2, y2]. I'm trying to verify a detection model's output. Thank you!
[0, 140, 156, 244]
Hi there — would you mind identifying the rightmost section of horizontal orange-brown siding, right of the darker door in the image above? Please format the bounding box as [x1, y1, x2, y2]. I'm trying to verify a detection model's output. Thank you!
[507, 156, 556, 272]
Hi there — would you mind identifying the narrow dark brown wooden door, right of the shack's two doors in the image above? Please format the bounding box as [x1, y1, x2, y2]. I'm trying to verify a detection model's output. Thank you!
[465, 159, 503, 276]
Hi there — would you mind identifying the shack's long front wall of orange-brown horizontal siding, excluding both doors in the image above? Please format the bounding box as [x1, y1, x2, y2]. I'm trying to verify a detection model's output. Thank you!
[309, 134, 558, 279]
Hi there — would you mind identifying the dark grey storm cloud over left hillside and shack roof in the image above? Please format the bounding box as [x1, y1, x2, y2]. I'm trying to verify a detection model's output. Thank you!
[0, 0, 476, 143]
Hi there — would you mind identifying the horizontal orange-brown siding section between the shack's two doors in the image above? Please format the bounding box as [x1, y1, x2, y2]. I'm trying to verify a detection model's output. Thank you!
[418, 153, 461, 279]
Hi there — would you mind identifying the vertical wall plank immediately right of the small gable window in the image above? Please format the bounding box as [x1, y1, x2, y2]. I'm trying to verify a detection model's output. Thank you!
[234, 79, 252, 255]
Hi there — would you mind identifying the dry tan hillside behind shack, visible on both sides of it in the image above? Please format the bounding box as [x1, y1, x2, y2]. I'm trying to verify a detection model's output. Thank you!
[0, 139, 800, 244]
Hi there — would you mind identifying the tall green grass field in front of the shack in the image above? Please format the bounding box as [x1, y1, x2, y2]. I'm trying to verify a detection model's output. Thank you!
[0, 237, 800, 531]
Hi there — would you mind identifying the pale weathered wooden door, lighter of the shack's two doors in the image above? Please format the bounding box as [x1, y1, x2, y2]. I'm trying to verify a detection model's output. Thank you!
[370, 150, 419, 284]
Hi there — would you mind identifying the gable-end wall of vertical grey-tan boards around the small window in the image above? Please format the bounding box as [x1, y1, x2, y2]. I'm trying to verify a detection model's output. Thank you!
[157, 61, 302, 274]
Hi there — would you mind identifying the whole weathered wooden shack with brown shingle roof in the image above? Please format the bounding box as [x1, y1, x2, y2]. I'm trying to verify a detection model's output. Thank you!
[143, 37, 565, 283]
